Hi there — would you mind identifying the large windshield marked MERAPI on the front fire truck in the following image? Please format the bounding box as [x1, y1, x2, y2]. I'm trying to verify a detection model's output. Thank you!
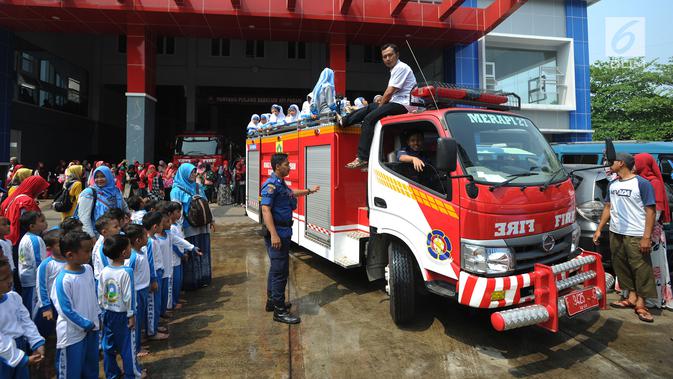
[445, 111, 567, 186]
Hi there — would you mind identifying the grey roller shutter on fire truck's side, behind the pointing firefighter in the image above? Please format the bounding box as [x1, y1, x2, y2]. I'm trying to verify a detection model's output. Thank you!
[306, 145, 332, 244]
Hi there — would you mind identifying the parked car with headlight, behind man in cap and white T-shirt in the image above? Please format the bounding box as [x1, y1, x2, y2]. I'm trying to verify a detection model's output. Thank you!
[563, 164, 673, 273]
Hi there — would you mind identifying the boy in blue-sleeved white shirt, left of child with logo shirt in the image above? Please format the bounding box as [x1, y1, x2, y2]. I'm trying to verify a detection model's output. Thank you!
[50, 231, 100, 379]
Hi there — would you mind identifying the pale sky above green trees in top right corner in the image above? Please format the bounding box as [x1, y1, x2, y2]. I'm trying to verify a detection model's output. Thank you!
[587, 0, 673, 63]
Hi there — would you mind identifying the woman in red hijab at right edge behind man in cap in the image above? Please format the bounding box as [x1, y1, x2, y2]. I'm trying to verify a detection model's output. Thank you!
[634, 153, 673, 309]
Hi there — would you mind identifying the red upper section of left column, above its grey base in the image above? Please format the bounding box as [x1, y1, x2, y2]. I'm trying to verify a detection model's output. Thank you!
[126, 25, 156, 97]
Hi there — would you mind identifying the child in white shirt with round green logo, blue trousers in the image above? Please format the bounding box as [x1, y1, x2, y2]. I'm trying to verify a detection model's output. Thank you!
[98, 234, 142, 379]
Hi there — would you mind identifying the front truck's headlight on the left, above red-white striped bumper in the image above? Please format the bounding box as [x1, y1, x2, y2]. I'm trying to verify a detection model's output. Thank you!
[460, 243, 515, 274]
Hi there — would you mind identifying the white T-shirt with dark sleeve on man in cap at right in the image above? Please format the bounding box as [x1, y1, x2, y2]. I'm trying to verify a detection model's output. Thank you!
[605, 175, 657, 237]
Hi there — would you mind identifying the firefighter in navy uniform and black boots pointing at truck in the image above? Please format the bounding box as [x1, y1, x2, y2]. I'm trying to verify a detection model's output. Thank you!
[261, 153, 320, 324]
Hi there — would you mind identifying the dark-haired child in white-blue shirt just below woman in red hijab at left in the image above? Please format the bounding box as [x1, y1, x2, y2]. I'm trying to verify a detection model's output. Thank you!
[18, 211, 47, 316]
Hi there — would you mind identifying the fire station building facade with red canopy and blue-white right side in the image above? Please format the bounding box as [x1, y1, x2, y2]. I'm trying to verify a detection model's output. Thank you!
[0, 0, 591, 169]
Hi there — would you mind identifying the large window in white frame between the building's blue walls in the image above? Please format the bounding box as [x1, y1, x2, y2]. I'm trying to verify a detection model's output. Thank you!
[484, 46, 566, 105]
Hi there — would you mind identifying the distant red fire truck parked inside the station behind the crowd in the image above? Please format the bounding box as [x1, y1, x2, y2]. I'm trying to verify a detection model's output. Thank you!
[173, 133, 224, 170]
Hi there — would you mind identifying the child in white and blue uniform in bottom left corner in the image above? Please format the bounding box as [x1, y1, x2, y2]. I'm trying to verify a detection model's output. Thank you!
[0, 257, 44, 379]
